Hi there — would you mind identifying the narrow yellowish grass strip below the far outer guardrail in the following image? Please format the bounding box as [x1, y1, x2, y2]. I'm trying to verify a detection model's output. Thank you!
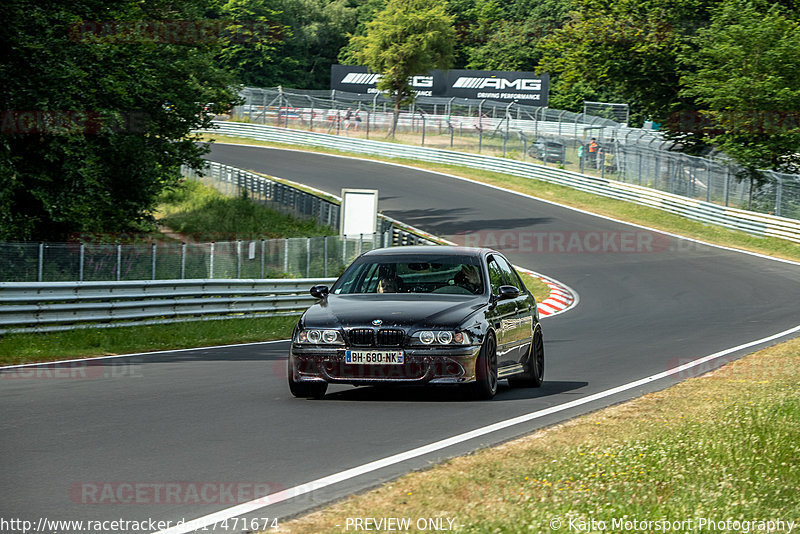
[204, 135, 800, 261]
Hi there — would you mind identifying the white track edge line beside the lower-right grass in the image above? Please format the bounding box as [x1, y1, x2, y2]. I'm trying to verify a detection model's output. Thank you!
[156, 325, 800, 534]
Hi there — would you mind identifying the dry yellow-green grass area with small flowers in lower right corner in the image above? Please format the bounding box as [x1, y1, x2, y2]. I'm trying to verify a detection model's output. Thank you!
[281, 338, 800, 534]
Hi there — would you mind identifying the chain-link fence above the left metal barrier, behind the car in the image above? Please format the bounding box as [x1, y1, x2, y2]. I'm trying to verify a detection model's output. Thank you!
[0, 232, 392, 282]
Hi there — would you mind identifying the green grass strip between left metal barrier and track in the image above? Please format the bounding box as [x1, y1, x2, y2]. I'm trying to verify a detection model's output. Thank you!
[0, 316, 298, 365]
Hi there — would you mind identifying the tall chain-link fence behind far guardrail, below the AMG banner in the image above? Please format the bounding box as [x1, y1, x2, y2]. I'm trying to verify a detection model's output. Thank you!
[223, 88, 800, 219]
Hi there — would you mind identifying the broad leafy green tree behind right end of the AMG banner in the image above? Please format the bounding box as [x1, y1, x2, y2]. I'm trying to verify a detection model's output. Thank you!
[539, 0, 716, 121]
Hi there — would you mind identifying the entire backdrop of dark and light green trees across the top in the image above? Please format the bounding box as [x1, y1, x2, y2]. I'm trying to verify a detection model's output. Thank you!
[0, 0, 800, 240]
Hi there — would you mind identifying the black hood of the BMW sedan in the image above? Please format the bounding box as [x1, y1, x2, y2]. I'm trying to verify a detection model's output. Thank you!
[303, 293, 488, 328]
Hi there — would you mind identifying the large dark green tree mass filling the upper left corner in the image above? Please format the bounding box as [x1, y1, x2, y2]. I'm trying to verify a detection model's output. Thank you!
[0, 0, 235, 241]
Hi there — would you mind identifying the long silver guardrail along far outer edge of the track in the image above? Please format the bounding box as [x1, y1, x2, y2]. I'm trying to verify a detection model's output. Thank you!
[206, 122, 800, 243]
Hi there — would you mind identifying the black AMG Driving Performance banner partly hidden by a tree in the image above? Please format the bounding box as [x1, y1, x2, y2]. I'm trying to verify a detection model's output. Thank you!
[331, 65, 550, 106]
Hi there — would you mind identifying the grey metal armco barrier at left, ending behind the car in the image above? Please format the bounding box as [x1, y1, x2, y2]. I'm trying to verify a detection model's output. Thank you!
[0, 278, 336, 334]
